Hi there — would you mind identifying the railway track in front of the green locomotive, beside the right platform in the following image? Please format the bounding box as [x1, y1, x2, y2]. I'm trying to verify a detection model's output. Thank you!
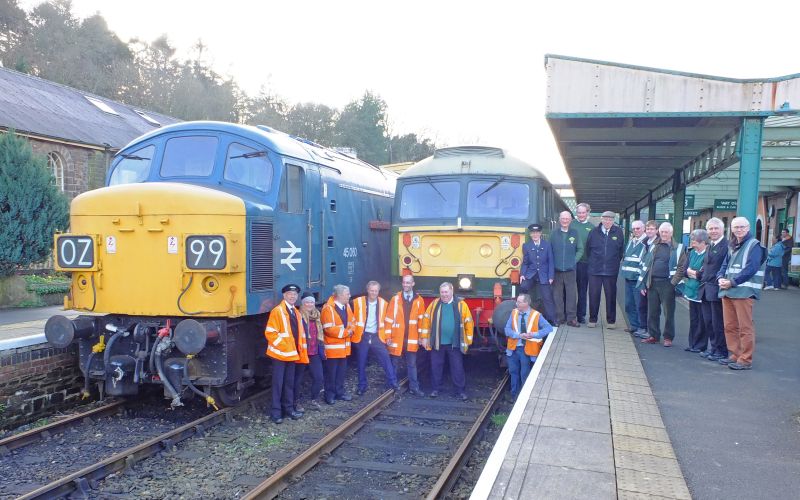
[243, 375, 508, 500]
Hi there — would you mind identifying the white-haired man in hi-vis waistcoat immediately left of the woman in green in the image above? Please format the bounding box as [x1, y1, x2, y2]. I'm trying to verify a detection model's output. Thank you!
[638, 222, 683, 347]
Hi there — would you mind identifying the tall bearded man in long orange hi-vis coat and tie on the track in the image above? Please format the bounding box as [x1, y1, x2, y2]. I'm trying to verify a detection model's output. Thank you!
[386, 274, 425, 396]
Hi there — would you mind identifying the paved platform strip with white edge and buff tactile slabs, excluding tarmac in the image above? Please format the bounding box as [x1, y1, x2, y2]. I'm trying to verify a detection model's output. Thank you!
[471, 312, 691, 499]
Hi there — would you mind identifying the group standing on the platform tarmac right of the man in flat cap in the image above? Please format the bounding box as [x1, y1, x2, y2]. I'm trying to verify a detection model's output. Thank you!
[622, 217, 764, 370]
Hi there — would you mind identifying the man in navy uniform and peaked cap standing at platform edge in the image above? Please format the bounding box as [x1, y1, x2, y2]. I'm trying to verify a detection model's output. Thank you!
[520, 223, 556, 323]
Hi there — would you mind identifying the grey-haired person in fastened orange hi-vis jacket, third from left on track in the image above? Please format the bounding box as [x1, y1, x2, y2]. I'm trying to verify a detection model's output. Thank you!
[320, 285, 355, 405]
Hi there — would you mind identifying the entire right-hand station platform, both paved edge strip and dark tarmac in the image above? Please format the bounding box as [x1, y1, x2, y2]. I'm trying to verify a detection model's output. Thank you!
[471, 286, 800, 499]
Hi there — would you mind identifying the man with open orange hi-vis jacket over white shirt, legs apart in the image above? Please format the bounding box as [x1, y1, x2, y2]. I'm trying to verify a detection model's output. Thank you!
[352, 281, 400, 396]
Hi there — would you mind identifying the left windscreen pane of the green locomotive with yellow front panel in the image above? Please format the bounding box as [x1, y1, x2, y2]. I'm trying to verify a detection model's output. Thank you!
[400, 181, 461, 219]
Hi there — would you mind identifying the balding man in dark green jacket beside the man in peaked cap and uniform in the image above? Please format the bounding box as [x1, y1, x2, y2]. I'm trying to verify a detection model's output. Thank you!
[550, 210, 583, 327]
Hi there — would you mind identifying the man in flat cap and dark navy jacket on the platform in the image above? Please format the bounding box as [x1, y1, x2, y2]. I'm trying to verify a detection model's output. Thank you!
[585, 211, 625, 329]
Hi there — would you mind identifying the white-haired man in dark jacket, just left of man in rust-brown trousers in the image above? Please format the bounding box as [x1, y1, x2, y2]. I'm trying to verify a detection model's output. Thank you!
[697, 217, 728, 361]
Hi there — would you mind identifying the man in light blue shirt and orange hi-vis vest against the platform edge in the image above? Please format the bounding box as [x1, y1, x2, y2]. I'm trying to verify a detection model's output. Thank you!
[505, 293, 553, 401]
